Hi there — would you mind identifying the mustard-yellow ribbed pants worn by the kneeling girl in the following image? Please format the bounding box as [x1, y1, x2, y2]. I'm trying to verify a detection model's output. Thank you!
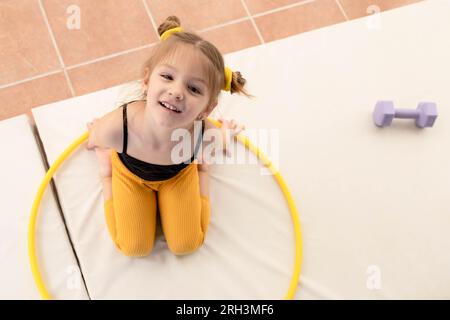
[104, 150, 210, 257]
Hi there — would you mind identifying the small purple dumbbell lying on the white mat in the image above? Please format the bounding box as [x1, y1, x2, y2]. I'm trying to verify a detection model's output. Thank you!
[373, 101, 437, 128]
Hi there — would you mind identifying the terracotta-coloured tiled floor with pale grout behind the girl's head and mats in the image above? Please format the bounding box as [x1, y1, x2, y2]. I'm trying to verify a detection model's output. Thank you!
[0, 0, 421, 120]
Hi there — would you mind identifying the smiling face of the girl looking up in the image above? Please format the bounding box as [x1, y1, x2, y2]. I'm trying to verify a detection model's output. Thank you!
[147, 45, 214, 128]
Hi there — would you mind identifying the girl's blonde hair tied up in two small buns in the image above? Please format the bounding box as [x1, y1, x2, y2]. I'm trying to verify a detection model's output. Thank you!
[142, 16, 253, 106]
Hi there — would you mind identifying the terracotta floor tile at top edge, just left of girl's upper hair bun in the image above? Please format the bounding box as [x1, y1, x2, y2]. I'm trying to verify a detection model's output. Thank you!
[42, 0, 158, 66]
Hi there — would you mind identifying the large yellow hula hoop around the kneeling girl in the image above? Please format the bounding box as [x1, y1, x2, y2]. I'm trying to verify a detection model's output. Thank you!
[28, 118, 302, 300]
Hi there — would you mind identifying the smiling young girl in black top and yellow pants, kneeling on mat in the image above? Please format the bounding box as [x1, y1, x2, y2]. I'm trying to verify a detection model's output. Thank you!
[86, 16, 249, 256]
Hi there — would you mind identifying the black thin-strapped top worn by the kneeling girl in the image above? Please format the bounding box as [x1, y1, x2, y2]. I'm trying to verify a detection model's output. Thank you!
[118, 103, 205, 181]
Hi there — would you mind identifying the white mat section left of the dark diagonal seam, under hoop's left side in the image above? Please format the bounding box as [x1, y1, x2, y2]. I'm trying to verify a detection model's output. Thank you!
[0, 115, 87, 299]
